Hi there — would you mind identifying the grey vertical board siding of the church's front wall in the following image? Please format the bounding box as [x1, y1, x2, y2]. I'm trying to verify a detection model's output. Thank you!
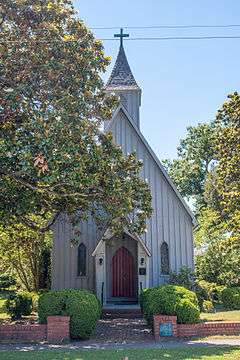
[52, 106, 193, 291]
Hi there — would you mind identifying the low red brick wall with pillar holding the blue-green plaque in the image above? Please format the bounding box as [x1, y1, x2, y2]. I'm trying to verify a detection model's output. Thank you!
[154, 315, 240, 340]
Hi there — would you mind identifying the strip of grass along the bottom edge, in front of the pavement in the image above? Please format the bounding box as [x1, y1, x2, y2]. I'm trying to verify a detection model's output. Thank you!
[0, 346, 240, 360]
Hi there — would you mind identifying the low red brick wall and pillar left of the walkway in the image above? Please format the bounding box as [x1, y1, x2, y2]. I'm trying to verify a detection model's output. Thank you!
[0, 316, 70, 342]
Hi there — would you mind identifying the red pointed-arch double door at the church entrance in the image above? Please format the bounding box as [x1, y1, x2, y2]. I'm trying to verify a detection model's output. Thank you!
[112, 246, 136, 298]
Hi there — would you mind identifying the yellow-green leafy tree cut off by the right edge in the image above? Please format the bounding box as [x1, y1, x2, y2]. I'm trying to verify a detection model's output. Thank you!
[206, 92, 240, 234]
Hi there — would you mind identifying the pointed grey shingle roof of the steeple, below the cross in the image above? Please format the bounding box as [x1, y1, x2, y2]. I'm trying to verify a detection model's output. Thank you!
[106, 45, 139, 89]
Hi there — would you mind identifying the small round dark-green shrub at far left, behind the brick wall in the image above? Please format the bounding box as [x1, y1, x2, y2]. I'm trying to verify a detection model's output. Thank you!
[4, 292, 32, 320]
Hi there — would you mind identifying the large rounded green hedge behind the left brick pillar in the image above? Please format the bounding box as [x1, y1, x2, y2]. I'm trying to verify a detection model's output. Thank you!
[38, 289, 101, 339]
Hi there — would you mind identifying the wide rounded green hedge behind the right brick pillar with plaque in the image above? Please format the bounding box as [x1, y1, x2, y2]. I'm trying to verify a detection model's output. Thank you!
[140, 285, 200, 324]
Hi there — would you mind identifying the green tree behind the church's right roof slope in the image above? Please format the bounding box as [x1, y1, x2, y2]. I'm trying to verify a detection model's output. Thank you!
[164, 123, 216, 211]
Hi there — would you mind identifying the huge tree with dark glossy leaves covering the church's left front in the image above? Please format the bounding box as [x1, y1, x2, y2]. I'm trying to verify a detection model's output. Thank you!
[0, 0, 152, 233]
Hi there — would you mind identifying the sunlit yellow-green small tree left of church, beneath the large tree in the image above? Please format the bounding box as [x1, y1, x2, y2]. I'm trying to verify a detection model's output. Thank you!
[0, 224, 51, 291]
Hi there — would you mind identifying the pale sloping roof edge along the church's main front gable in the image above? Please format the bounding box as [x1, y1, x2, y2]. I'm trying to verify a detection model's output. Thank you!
[104, 104, 197, 226]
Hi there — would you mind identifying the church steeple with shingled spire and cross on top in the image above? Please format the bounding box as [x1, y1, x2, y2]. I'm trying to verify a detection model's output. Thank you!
[106, 29, 141, 127]
